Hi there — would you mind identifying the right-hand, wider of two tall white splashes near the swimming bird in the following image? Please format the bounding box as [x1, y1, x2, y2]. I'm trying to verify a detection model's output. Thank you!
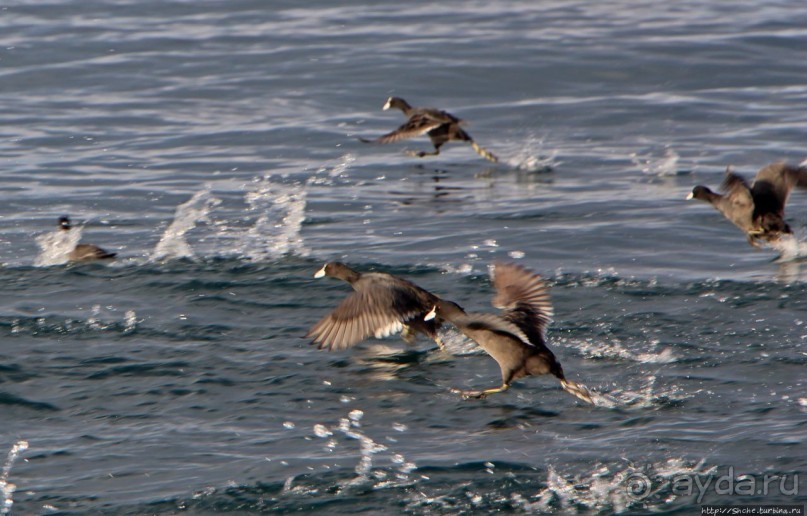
[240, 177, 310, 261]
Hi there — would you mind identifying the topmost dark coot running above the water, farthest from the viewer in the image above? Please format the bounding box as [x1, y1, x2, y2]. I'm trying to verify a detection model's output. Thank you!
[360, 97, 499, 163]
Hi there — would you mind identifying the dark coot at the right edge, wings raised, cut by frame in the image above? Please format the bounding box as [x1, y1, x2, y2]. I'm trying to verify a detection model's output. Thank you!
[687, 161, 807, 247]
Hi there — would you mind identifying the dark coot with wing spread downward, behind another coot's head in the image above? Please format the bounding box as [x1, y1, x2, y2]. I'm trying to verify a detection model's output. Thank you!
[306, 262, 443, 350]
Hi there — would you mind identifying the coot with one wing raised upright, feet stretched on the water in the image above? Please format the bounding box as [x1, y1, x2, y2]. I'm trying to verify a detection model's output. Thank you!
[426, 263, 593, 403]
